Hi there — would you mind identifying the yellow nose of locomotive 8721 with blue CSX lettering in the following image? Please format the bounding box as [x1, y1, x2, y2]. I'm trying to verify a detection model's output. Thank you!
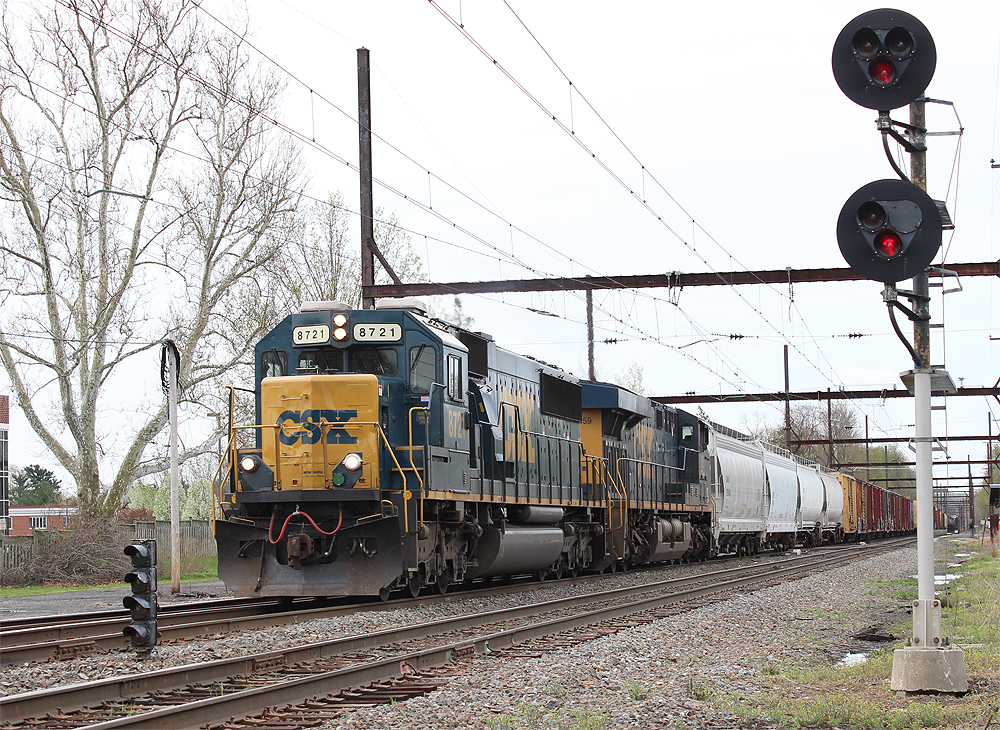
[261, 374, 379, 490]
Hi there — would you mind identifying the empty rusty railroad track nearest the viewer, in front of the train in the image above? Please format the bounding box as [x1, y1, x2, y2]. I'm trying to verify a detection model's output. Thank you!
[0, 544, 912, 730]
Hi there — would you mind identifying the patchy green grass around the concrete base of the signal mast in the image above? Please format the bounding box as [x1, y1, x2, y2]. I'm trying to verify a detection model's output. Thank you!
[704, 541, 1000, 730]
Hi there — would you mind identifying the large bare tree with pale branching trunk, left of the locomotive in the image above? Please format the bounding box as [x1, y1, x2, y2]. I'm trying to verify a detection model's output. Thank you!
[0, 0, 303, 514]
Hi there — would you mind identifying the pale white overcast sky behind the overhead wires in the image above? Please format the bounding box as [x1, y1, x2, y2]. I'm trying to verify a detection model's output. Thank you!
[1, 0, 1000, 494]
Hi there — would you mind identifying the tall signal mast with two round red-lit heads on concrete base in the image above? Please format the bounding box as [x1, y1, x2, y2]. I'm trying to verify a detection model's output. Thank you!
[833, 9, 969, 693]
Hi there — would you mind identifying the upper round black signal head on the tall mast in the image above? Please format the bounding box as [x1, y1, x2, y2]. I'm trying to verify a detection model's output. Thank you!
[833, 9, 937, 111]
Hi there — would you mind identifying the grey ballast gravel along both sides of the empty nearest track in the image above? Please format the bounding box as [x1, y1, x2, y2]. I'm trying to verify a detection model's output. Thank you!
[0, 548, 936, 730]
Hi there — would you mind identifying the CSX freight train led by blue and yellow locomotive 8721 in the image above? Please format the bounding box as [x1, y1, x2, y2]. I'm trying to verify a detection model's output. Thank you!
[215, 300, 916, 599]
